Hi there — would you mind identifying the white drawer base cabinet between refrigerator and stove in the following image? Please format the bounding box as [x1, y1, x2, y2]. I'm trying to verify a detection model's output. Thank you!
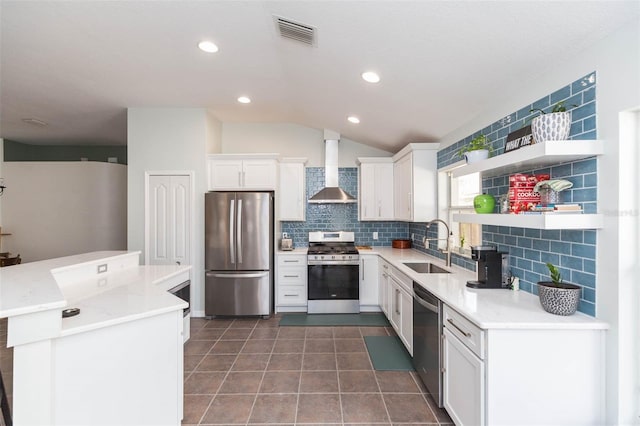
[275, 253, 307, 312]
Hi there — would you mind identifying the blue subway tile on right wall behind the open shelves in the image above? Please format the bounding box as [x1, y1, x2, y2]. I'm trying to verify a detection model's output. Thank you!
[436, 72, 598, 315]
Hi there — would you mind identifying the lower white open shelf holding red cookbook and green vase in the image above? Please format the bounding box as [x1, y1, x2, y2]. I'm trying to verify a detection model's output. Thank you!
[453, 213, 604, 229]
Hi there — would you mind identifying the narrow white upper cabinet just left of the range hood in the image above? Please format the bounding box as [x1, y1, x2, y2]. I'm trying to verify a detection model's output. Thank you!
[276, 158, 307, 221]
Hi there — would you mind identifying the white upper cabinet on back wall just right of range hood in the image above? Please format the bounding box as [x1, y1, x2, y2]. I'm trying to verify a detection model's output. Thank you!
[358, 157, 394, 220]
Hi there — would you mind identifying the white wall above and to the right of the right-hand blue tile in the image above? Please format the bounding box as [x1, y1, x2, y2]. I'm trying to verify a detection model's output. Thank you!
[441, 20, 640, 425]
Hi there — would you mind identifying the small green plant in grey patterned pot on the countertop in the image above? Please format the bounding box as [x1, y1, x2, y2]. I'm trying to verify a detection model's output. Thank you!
[538, 262, 582, 315]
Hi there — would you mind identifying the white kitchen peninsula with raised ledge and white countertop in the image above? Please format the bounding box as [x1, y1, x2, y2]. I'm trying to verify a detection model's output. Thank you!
[0, 251, 191, 425]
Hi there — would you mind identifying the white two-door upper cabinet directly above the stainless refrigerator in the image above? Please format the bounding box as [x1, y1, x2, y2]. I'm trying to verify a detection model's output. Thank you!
[209, 154, 278, 191]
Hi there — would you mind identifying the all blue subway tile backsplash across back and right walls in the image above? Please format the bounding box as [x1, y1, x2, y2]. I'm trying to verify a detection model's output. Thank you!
[282, 72, 598, 316]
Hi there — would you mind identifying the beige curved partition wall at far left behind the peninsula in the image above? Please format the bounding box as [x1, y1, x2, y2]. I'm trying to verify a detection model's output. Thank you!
[2, 161, 127, 262]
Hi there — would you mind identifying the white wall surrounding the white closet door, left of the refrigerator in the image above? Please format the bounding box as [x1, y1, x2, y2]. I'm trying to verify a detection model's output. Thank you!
[127, 108, 209, 316]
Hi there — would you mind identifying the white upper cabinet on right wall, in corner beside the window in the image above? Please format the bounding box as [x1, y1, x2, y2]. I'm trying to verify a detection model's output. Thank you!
[393, 143, 440, 222]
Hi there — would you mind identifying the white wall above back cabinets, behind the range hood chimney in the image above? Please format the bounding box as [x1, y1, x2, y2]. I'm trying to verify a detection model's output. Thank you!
[222, 123, 393, 167]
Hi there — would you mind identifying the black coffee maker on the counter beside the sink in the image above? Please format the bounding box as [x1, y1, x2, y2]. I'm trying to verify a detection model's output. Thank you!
[467, 246, 509, 288]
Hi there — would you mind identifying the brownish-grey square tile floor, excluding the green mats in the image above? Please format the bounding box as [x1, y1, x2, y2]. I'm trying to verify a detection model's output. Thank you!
[183, 318, 452, 425]
